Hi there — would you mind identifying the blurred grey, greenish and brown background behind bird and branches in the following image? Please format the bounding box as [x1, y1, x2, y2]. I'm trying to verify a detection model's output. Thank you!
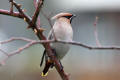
[0, 0, 120, 80]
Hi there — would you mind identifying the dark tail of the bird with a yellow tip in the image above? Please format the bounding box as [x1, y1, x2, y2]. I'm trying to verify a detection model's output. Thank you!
[41, 60, 54, 76]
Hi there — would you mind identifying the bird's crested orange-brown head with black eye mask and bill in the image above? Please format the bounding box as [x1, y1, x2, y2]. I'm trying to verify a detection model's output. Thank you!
[52, 13, 75, 23]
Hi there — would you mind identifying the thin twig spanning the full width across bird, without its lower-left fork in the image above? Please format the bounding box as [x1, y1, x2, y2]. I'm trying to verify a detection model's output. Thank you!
[0, 37, 120, 50]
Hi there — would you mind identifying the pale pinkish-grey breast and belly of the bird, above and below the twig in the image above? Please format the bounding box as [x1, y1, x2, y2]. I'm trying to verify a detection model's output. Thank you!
[52, 21, 73, 59]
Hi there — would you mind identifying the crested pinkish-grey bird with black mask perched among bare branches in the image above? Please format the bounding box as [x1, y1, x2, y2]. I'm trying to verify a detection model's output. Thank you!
[40, 12, 75, 76]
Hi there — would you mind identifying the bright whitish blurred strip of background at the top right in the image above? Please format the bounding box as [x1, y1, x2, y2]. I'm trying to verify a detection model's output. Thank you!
[52, 0, 120, 11]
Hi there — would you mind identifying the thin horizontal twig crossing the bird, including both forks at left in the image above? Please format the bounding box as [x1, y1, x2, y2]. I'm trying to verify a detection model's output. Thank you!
[0, 37, 120, 67]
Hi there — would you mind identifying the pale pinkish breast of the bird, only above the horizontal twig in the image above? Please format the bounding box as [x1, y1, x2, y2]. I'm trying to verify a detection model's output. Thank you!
[53, 21, 73, 41]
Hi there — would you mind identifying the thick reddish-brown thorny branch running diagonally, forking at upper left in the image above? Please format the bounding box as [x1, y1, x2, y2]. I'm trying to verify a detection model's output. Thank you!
[2, 0, 68, 80]
